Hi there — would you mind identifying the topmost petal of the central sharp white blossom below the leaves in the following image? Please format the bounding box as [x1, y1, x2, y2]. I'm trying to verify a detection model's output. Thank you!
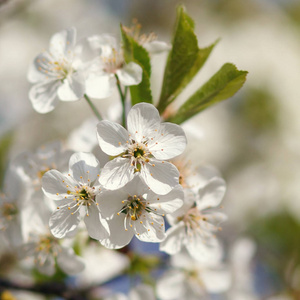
[127, 103, 160, 142]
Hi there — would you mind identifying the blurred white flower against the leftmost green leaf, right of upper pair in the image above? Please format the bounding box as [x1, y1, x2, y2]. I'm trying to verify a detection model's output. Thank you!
[81, 34, 143, 99]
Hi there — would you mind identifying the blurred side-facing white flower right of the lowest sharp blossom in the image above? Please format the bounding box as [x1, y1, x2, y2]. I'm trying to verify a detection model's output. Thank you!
[160, 177, 226, 261]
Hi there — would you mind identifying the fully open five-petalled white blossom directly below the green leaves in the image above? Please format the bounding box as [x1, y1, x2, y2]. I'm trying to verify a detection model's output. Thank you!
[97, 103, 186, 194]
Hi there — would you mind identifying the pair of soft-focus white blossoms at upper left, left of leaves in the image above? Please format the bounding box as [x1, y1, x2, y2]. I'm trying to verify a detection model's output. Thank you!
[28, 28, 169, 113]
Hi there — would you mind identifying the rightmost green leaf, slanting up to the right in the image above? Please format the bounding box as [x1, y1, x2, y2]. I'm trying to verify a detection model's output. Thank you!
[167, 63, 248, 124]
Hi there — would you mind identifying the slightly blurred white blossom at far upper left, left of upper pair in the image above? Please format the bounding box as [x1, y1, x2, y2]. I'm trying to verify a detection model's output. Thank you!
[28, 28, 85, 113]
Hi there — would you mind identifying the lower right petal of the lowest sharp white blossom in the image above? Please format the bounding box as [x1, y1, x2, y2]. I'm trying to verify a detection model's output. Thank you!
[132, 213, 166, 243]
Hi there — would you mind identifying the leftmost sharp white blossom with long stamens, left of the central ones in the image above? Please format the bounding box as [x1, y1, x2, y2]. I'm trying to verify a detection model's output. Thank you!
[42, 152, 108, 240]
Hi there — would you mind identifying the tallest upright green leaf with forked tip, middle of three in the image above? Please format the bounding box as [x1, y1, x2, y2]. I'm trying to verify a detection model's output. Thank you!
[157, 6, 217, 113]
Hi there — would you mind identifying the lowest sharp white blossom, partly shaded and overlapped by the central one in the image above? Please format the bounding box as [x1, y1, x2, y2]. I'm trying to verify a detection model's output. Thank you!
[97, 176, 183, 248]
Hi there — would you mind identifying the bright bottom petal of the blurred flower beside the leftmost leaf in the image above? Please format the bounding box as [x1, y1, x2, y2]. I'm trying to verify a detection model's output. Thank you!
[85, 72, 116, 99]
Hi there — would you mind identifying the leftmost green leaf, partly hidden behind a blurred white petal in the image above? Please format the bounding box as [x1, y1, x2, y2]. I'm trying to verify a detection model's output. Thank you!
[121, 25, 152, 105]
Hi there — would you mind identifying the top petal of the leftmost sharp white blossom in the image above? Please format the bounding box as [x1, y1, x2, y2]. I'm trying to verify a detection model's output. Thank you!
[69, 152, 100, 184]
